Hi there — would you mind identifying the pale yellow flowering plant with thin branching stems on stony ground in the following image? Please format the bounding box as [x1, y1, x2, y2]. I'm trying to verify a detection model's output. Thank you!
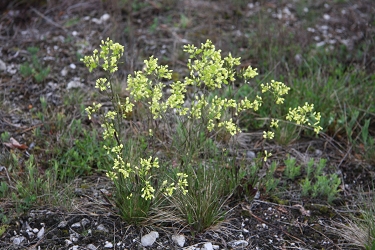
[82, 39, 321, 224]
